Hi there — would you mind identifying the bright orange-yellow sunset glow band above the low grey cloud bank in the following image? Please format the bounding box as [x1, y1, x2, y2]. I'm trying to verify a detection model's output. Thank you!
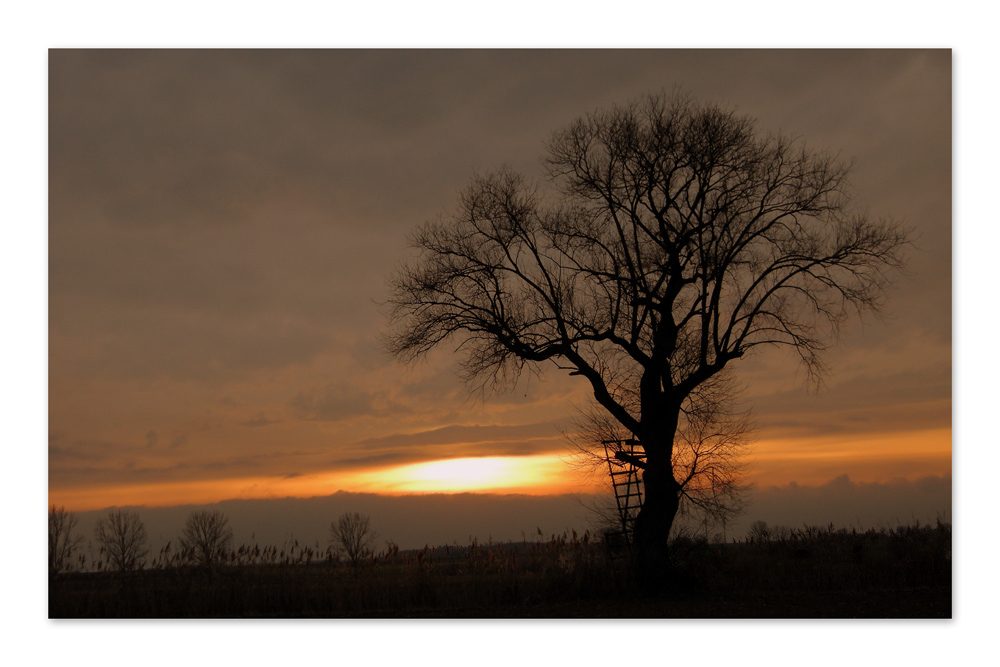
[49, 429, 952, 511]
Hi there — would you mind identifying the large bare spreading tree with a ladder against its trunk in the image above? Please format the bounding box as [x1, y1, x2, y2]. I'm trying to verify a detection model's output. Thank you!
[387, 94, 908, 576]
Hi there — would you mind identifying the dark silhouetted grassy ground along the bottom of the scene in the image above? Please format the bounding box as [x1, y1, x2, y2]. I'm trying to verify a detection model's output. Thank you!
[49, 525, 952, 618]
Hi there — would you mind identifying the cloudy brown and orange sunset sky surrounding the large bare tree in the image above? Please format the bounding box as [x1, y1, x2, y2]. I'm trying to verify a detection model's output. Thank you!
[48, 49, 952, 539]
